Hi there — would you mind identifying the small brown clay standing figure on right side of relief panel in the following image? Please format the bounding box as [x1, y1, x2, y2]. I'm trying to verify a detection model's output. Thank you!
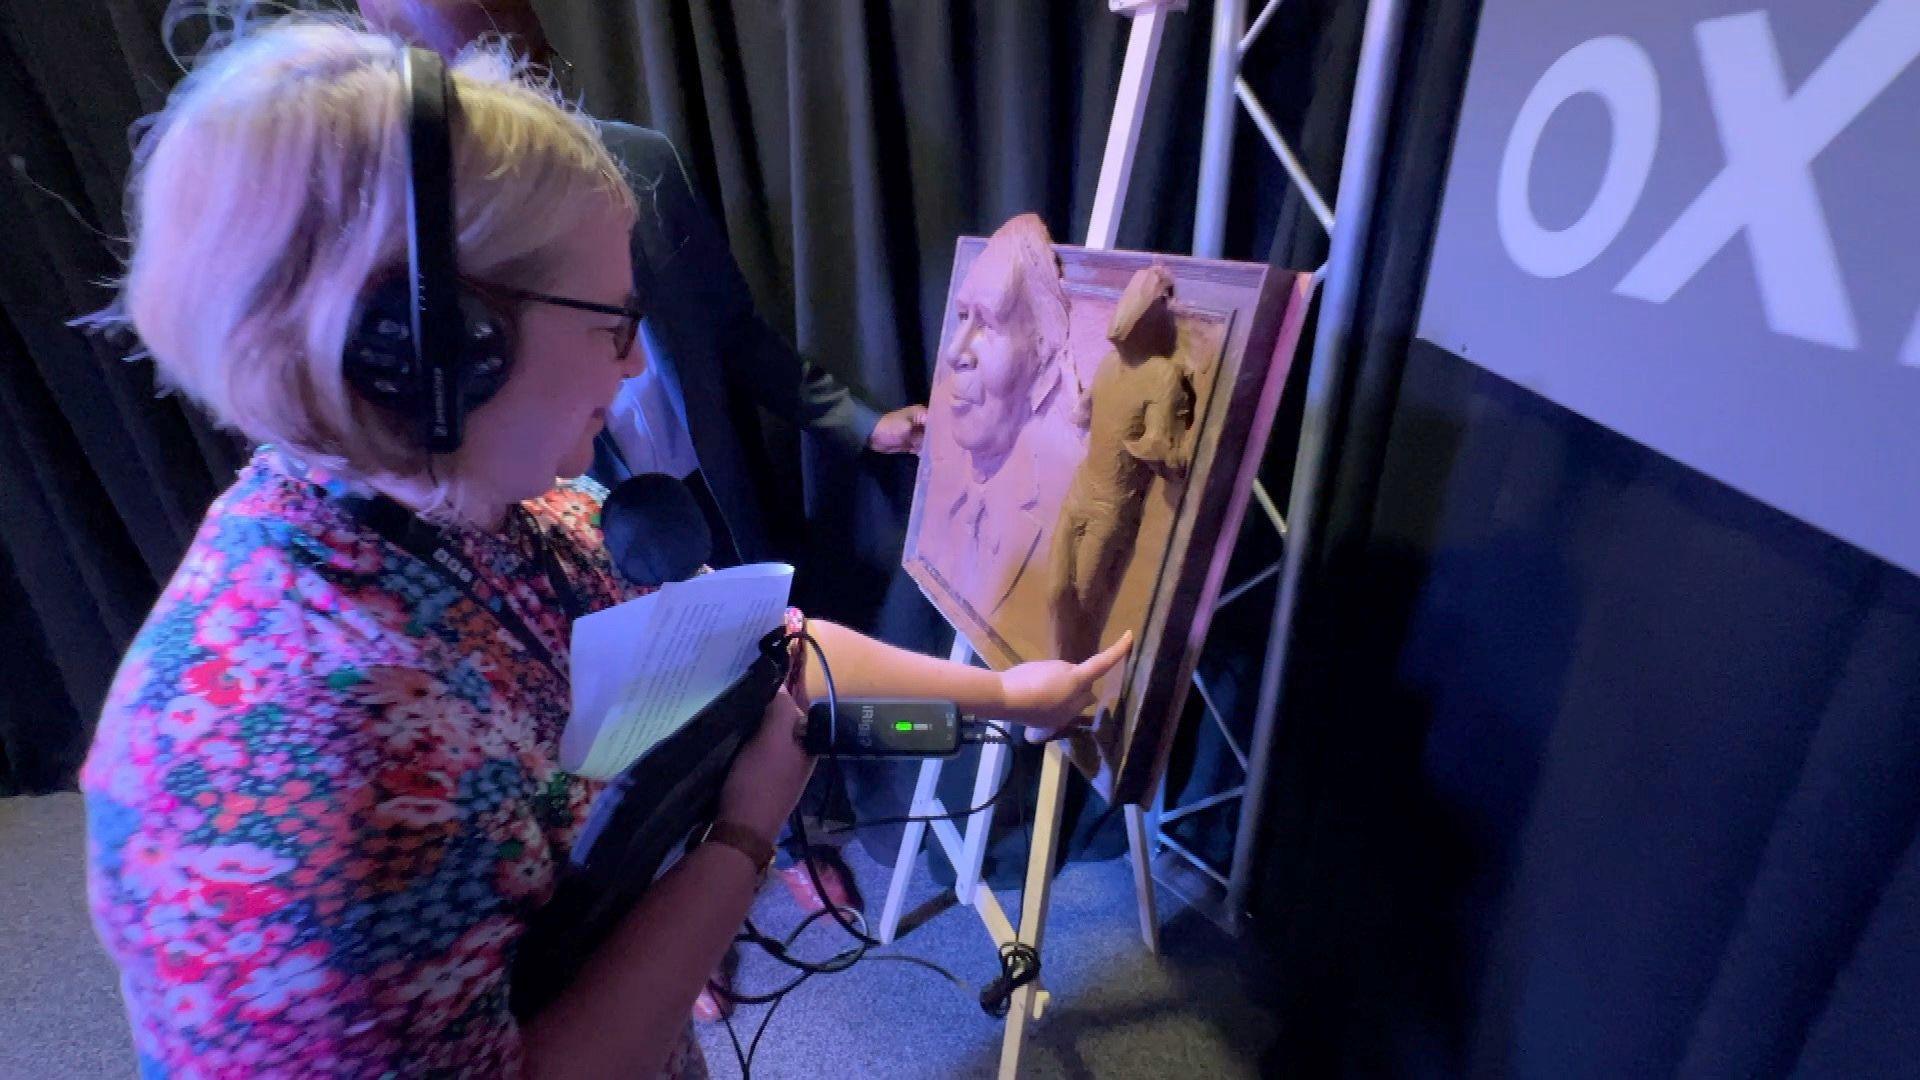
[1052, 267, 1194, 659]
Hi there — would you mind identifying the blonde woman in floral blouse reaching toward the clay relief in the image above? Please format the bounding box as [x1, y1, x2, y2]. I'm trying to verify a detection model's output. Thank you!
[83, 19, 1125, 1076]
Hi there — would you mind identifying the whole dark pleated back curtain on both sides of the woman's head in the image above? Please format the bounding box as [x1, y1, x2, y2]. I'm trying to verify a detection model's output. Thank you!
[0, 0, 1359, 824]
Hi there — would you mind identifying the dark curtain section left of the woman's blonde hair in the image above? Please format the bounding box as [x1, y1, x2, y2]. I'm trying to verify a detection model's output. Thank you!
[0, 0, 240, 794]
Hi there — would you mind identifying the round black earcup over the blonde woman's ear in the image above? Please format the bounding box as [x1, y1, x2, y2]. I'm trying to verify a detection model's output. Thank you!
[340, 277, 513, 441]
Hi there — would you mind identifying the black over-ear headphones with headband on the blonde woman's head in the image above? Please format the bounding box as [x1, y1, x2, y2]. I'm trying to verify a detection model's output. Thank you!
[342, 48, 513, 454]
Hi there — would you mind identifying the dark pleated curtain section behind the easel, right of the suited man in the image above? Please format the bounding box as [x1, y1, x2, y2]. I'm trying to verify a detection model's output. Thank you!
[540, 0, 1346, 634]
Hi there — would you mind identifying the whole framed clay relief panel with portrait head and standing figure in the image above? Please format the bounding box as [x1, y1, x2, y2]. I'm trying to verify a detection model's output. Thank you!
[904, 215, 1306, 799]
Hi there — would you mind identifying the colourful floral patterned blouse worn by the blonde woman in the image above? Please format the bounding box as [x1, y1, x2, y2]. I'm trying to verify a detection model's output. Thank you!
[81, 450, 705, 1078]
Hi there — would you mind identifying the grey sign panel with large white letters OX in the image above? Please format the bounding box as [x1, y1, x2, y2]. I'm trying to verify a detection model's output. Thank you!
[1419, 0, 1920, 573]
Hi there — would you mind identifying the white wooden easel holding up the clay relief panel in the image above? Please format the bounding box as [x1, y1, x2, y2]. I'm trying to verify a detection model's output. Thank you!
[879, 0, 1187, 1080]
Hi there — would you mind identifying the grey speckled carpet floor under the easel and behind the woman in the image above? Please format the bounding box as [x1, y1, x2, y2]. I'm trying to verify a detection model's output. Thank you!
[11, 796, 1273, 1080]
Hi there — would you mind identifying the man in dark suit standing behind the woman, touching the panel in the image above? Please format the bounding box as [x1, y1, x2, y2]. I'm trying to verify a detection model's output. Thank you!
[359, 0, 925, 1019]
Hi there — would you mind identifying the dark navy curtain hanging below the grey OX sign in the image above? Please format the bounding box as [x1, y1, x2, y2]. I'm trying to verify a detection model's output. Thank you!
[1260, 0, 1920, 1076]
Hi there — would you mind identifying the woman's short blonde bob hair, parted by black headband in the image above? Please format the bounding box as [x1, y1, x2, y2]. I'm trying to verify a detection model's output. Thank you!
[104, 15, 634, 477]
